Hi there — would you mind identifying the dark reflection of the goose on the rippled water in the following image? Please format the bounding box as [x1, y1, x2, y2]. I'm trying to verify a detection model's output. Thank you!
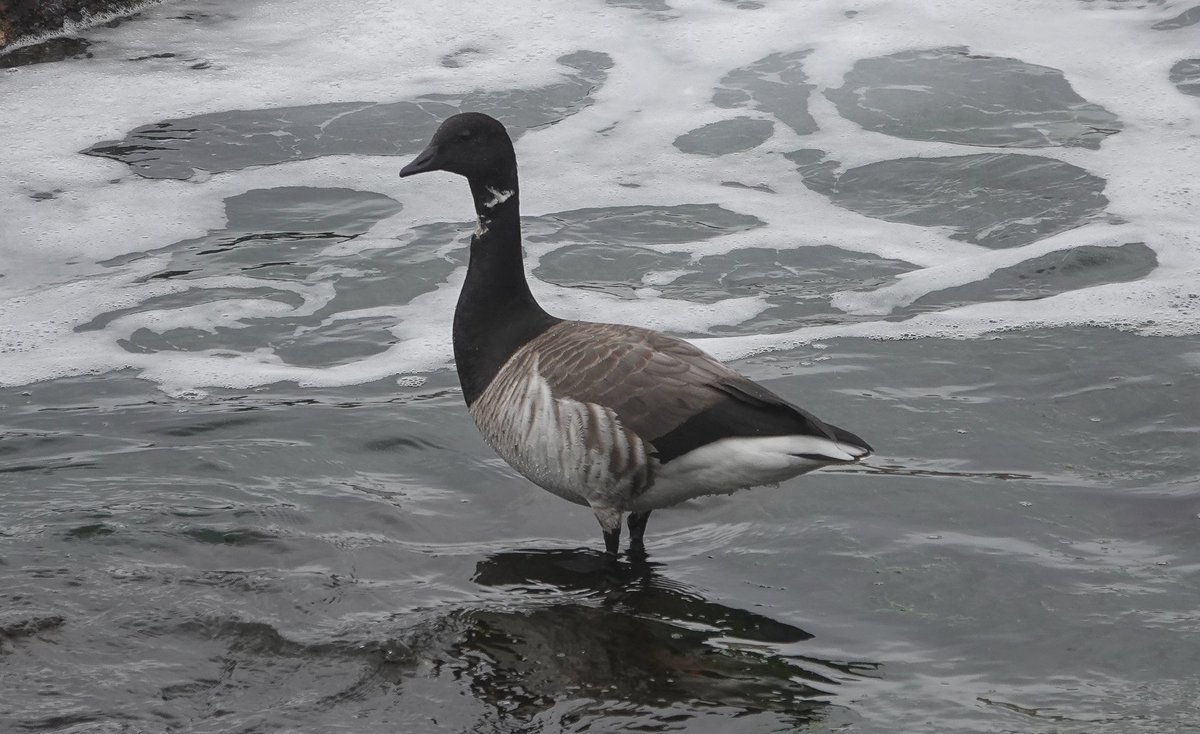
[449, 551, 877, 730]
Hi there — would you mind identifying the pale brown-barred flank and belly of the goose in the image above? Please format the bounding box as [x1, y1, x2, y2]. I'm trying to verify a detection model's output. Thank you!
[470, 360, 652, 509]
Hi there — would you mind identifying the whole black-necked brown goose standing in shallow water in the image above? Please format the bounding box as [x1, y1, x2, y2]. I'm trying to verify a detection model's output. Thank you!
[400, 113, 871, 555]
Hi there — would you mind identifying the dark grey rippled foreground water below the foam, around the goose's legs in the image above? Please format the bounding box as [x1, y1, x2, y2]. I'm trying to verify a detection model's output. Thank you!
[0, 330, 1200, 732]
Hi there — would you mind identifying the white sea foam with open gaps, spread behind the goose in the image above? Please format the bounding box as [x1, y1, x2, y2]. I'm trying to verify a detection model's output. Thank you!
[0, 0, 1200, 392]
